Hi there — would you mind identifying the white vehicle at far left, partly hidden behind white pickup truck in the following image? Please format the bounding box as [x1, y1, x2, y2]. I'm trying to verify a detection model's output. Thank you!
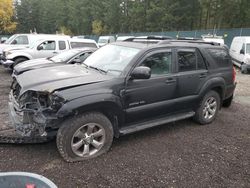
[0, 34, 70, 60]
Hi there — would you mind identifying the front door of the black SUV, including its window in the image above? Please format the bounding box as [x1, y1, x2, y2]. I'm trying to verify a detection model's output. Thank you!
[124, 49, 177, 123]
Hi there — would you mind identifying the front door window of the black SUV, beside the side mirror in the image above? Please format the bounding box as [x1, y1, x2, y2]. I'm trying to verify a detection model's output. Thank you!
[141, 52, 172, 76]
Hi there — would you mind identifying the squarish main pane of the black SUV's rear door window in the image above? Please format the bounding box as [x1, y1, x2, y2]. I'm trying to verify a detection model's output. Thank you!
[178, 51, 196, 72]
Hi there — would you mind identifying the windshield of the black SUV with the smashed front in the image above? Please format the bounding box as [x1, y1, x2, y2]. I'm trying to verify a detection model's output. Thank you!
[84, 45, 140, 75]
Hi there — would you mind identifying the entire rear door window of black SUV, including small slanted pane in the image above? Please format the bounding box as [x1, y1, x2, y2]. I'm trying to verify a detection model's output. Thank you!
[178, 50, 206, 72]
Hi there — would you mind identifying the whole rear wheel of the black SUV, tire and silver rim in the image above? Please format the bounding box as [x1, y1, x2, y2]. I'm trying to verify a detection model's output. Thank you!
[194, 91, 221, 125]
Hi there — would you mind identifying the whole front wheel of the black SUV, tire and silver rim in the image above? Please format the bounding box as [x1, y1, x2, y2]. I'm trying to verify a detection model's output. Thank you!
[57, 112, 114, 162]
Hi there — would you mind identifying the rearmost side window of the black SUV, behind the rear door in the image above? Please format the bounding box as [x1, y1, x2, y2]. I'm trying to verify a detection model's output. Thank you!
[208, 48, 231, 67]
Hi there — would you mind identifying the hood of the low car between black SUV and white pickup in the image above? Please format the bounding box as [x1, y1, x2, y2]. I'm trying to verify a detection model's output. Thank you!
[14, 58, 54, 74]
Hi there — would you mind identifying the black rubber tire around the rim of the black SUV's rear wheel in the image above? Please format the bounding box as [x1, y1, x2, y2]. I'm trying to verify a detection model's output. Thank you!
[194, 90, 221, 125]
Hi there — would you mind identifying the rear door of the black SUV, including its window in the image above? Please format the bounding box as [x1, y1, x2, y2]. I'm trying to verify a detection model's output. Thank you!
[176, 48, 208, 110]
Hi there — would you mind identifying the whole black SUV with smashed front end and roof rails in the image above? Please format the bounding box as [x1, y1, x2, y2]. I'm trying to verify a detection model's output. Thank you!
[9, 40, 235, 162]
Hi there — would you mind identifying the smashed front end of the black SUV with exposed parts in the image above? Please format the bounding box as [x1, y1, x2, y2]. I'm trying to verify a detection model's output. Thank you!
[9, 81, 65, 140]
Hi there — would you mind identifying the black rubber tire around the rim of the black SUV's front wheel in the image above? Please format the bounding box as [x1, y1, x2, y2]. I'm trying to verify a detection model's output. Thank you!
[56, 112, 114, 162]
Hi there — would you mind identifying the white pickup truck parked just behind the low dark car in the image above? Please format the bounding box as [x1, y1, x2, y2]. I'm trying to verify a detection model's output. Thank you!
[2, 36, 97, 69]
